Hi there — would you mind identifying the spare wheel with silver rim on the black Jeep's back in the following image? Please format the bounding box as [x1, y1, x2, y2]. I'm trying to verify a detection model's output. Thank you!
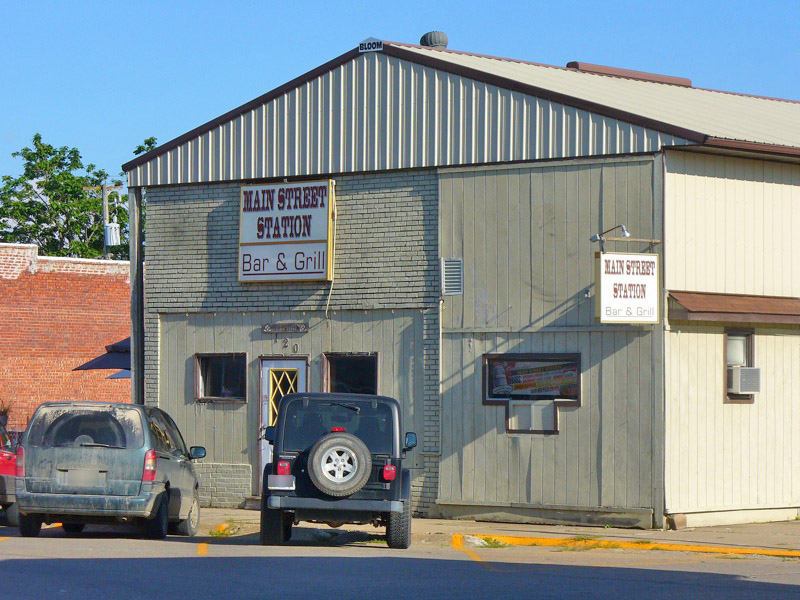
[308, 433, 372, 498]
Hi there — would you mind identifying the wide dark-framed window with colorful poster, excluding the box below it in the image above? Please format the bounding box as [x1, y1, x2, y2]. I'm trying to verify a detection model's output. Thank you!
[488, 358, 580, 400]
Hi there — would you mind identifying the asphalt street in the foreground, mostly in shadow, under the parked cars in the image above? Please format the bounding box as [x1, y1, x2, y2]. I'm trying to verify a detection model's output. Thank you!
[0, 523, 800, 600]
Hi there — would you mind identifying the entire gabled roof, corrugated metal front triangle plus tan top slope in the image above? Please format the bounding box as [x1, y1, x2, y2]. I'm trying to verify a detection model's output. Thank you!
[122, 42, 800, 185]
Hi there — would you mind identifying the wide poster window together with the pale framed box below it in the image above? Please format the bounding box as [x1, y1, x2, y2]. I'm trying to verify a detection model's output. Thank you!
[483, 354, 581, 434]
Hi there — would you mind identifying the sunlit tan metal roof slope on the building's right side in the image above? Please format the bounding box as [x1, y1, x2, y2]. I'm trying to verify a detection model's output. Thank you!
[392, 43, 800, 147]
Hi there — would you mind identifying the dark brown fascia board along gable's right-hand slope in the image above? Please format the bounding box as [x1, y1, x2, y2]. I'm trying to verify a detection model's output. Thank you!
[383, 42, 708, 143]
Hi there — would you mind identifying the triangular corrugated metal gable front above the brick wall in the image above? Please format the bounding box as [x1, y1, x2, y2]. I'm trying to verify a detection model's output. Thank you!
[128, 53, 687, 186]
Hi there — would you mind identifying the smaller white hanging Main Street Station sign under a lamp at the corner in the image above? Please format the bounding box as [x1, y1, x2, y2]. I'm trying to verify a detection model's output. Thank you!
[595, 252, 660, 324]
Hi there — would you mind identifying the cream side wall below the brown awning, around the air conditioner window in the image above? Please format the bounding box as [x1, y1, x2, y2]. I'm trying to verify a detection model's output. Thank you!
[666, 325, 800, 513]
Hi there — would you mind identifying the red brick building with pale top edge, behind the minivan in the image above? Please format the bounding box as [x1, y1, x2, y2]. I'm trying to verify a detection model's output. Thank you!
[0, 244, 131, 430]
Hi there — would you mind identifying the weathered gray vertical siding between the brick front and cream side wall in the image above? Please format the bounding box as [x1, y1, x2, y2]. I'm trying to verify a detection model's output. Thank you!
[439, 158, 663, 509]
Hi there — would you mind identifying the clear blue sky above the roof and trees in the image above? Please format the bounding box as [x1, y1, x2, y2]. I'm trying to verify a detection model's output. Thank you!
[0, 0, 800, 180]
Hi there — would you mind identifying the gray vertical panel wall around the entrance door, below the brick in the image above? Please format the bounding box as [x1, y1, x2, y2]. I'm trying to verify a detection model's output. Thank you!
[158, 310, 425, 489]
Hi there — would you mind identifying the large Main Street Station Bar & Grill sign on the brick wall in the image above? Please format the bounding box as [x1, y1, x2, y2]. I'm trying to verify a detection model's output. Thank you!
[239, 179, 334, 282]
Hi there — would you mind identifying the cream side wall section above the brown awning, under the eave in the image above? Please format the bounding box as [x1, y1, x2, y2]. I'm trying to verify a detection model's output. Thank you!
[664, 152, 800, 296]
